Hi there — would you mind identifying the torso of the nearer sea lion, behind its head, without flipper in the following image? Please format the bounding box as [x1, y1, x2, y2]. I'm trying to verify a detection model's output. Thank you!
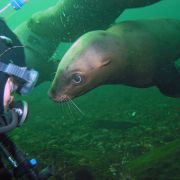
[107, 20, 180, 87]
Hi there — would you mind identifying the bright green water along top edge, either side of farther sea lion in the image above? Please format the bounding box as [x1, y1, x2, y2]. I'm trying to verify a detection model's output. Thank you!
[0, 0, 180, 28]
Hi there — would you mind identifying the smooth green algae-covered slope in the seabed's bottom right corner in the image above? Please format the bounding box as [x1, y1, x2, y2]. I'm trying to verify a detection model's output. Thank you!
[126, 139, 180, 180]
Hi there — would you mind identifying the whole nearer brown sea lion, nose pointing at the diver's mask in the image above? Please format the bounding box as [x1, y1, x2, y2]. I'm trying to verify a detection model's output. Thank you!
[49, 19, 180, 102]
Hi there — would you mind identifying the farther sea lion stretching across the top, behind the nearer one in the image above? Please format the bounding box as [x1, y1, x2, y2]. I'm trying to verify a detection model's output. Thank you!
[28, 0, 161, 42]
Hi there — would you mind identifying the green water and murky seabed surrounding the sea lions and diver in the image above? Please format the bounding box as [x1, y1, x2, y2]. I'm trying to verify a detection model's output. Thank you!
[0, 0, 180, 180]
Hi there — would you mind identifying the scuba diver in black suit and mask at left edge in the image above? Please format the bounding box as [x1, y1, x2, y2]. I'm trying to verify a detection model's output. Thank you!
[0, 18, 52, 180]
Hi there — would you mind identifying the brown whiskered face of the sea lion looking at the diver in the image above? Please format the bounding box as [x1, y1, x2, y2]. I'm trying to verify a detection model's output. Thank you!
[49, 30, 112, 102]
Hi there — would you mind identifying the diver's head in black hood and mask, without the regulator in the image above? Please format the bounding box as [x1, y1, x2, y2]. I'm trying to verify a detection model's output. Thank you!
[0, 19, 38, 115]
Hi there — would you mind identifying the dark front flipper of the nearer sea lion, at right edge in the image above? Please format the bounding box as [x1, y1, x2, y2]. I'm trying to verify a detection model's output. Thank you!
[155, 63, 180, 97]
